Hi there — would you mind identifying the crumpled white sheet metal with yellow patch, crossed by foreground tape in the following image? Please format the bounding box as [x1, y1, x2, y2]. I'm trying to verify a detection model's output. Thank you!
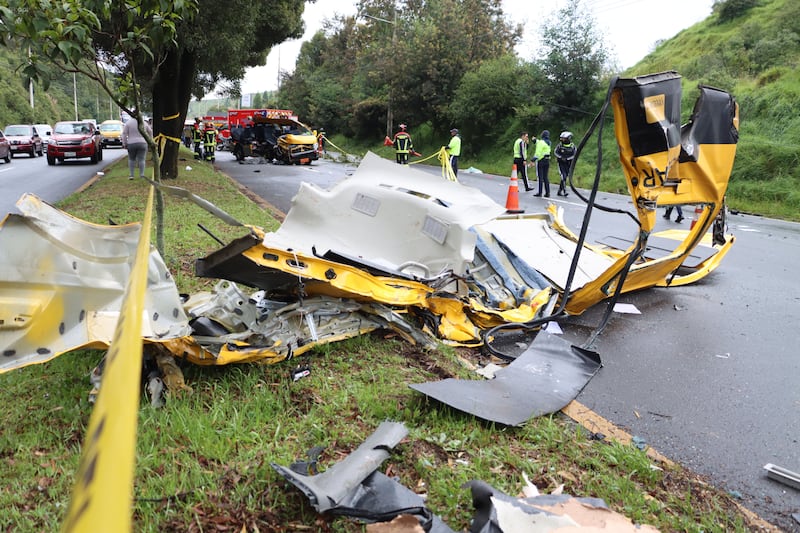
[0, 194, 190, 372]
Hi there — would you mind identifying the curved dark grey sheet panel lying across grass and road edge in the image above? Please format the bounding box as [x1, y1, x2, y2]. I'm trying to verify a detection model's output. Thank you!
[409, 331, 602, 426]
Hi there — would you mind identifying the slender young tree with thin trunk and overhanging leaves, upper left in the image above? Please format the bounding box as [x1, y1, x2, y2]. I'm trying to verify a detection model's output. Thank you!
[0, 0, 196, 253]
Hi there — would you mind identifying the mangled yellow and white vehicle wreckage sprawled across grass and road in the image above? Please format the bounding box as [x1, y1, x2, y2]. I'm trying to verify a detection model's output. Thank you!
[0, 72, 738, 424]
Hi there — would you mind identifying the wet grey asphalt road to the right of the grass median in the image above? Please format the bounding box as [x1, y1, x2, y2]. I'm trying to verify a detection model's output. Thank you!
[217, 149, 800, 531]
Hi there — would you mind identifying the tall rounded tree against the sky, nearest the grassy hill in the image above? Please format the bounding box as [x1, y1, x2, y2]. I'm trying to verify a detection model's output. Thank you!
[538, 0, 609, 120]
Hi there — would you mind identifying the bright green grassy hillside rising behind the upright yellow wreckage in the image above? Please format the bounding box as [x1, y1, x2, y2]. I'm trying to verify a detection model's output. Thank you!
[628, 0, 800, 220]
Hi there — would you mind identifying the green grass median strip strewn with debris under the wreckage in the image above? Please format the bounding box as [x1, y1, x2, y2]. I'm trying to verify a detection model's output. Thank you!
[0, 147, 764, 532]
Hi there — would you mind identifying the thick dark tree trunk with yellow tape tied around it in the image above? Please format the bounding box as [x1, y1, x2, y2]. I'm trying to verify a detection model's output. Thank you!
[153, 50, 196, 179]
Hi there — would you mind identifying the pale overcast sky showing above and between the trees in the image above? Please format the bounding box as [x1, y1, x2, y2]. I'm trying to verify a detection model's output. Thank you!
[242, 0, 713, 93]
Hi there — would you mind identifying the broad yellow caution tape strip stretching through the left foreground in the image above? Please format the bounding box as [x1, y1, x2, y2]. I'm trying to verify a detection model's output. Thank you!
[61, 187, 155, 533]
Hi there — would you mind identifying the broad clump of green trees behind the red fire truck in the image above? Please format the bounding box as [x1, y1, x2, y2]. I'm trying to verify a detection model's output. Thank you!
[281, 0, 521, 137]
